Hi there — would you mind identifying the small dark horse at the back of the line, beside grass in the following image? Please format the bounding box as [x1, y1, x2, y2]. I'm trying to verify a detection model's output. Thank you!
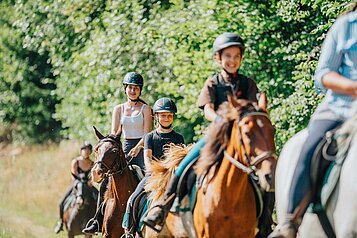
[63, 174, 98, 238]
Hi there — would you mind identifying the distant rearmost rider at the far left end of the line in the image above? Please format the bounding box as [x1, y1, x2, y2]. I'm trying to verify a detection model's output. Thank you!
[55, 141, 95, 234]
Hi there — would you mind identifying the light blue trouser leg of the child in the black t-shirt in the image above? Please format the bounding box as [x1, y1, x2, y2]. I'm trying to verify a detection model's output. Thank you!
[122, 175, 148, 233]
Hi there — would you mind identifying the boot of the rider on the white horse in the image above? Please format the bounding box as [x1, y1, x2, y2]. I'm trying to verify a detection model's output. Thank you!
[268, 214, 301, 238]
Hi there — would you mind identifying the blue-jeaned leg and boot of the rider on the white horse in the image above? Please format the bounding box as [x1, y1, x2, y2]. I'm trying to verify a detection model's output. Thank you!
[269, 120, 342, 238]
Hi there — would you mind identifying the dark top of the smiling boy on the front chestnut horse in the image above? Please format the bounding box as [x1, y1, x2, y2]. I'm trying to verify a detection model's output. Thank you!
[197, 73, 258, 109]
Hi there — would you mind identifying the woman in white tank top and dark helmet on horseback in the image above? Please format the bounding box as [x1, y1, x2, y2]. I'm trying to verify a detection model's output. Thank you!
[83, 72, 152, 234]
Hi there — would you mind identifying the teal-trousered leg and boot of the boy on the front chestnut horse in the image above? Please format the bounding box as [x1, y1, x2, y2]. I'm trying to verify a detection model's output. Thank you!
[143, 137, 206, 231]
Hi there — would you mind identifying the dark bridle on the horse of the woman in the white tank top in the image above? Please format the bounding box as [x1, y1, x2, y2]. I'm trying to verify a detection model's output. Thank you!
[94, 137, 130, 177]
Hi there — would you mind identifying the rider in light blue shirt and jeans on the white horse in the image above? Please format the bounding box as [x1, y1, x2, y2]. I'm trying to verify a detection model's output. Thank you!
[269, 2, 357, 238]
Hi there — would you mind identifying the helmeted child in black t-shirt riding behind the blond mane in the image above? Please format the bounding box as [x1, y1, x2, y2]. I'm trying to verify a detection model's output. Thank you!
[123, 98, 184, 236]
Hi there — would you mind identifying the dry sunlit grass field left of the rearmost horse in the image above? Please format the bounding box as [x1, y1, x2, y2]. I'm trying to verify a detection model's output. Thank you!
[0, 141, 96, 238]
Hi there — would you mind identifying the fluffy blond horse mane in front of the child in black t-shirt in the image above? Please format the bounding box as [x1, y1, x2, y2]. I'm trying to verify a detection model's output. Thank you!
[145, 143, 192, 201]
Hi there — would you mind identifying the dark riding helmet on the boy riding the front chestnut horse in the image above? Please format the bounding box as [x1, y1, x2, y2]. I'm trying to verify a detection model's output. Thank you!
[213, 32, 245, 55]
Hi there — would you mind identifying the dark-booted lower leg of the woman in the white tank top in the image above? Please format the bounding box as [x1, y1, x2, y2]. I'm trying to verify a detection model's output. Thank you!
[82, 178, 109, 234]
